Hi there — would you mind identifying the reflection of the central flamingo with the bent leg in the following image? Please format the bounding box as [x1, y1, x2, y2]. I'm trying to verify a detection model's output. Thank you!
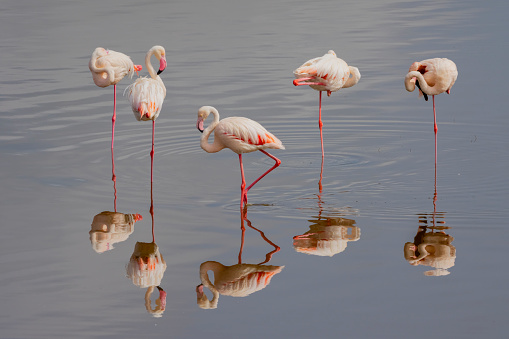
[196, 207, 284, 309]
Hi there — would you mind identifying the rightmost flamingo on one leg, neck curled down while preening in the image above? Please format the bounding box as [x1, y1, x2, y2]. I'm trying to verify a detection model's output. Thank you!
[405, 58, 458, 164]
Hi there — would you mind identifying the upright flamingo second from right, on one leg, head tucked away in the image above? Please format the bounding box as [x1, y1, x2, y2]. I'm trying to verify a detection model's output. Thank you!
[293, 50, 361, 158]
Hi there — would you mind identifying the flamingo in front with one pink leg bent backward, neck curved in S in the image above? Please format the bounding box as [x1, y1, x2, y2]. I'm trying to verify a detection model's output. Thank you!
[196, 106, 285, 208]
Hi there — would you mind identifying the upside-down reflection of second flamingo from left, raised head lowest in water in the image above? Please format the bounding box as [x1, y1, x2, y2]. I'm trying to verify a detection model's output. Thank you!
[126, 177, 166, 317]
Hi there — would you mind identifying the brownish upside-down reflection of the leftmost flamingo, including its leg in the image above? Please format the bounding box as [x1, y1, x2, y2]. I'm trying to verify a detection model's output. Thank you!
[89, 148, 143, 253]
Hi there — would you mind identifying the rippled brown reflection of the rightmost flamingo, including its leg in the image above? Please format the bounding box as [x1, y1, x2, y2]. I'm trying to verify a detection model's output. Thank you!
[404, 151, 456, 276]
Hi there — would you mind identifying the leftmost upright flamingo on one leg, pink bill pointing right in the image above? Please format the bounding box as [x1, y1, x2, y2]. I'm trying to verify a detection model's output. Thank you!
[88, 47, 142, 150]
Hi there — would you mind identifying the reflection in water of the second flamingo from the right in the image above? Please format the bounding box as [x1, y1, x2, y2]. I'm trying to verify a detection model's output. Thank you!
[293, 187, 361, 257]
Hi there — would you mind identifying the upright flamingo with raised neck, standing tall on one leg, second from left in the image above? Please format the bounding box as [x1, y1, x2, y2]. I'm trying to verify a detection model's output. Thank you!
[124, 46, 166, 182]
